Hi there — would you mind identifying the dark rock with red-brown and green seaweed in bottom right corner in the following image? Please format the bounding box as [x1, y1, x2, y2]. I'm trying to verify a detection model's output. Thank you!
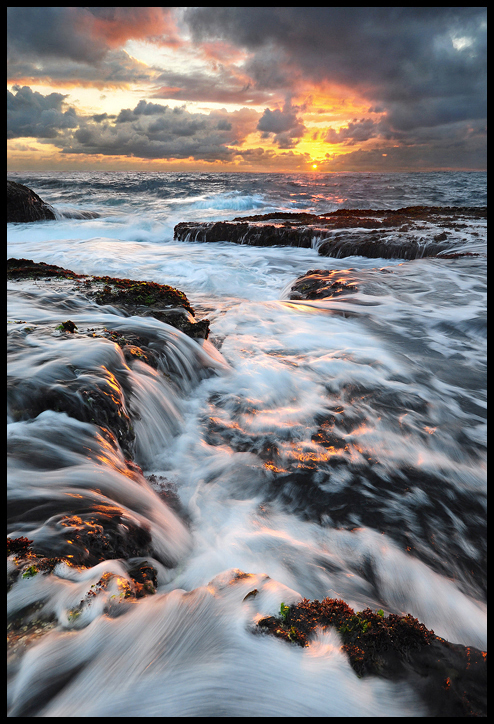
[257, 598, 487, 717]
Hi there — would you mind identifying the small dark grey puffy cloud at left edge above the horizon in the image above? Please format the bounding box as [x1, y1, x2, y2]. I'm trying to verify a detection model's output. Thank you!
[7, 86, 79, 139]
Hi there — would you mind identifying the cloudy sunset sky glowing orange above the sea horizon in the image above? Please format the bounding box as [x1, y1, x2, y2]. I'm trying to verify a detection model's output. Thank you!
[7, 7, 487, 173]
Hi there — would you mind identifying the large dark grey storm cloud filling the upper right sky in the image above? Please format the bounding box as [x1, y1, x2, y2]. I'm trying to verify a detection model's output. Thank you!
[185, 7, 486, 135]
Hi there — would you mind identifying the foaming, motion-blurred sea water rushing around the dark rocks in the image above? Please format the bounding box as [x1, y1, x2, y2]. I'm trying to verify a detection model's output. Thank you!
[7, 172, 487, 717]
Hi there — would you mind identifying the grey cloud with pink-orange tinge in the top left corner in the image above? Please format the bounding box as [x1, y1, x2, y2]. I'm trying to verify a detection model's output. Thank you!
[7, 7, 173, 87]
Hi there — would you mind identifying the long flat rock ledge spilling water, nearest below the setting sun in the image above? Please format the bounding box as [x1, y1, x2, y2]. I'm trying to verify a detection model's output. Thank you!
[174, 206, 487, 259]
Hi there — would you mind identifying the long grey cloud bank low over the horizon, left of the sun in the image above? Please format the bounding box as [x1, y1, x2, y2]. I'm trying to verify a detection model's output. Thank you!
[7, 86, 260, 162]
